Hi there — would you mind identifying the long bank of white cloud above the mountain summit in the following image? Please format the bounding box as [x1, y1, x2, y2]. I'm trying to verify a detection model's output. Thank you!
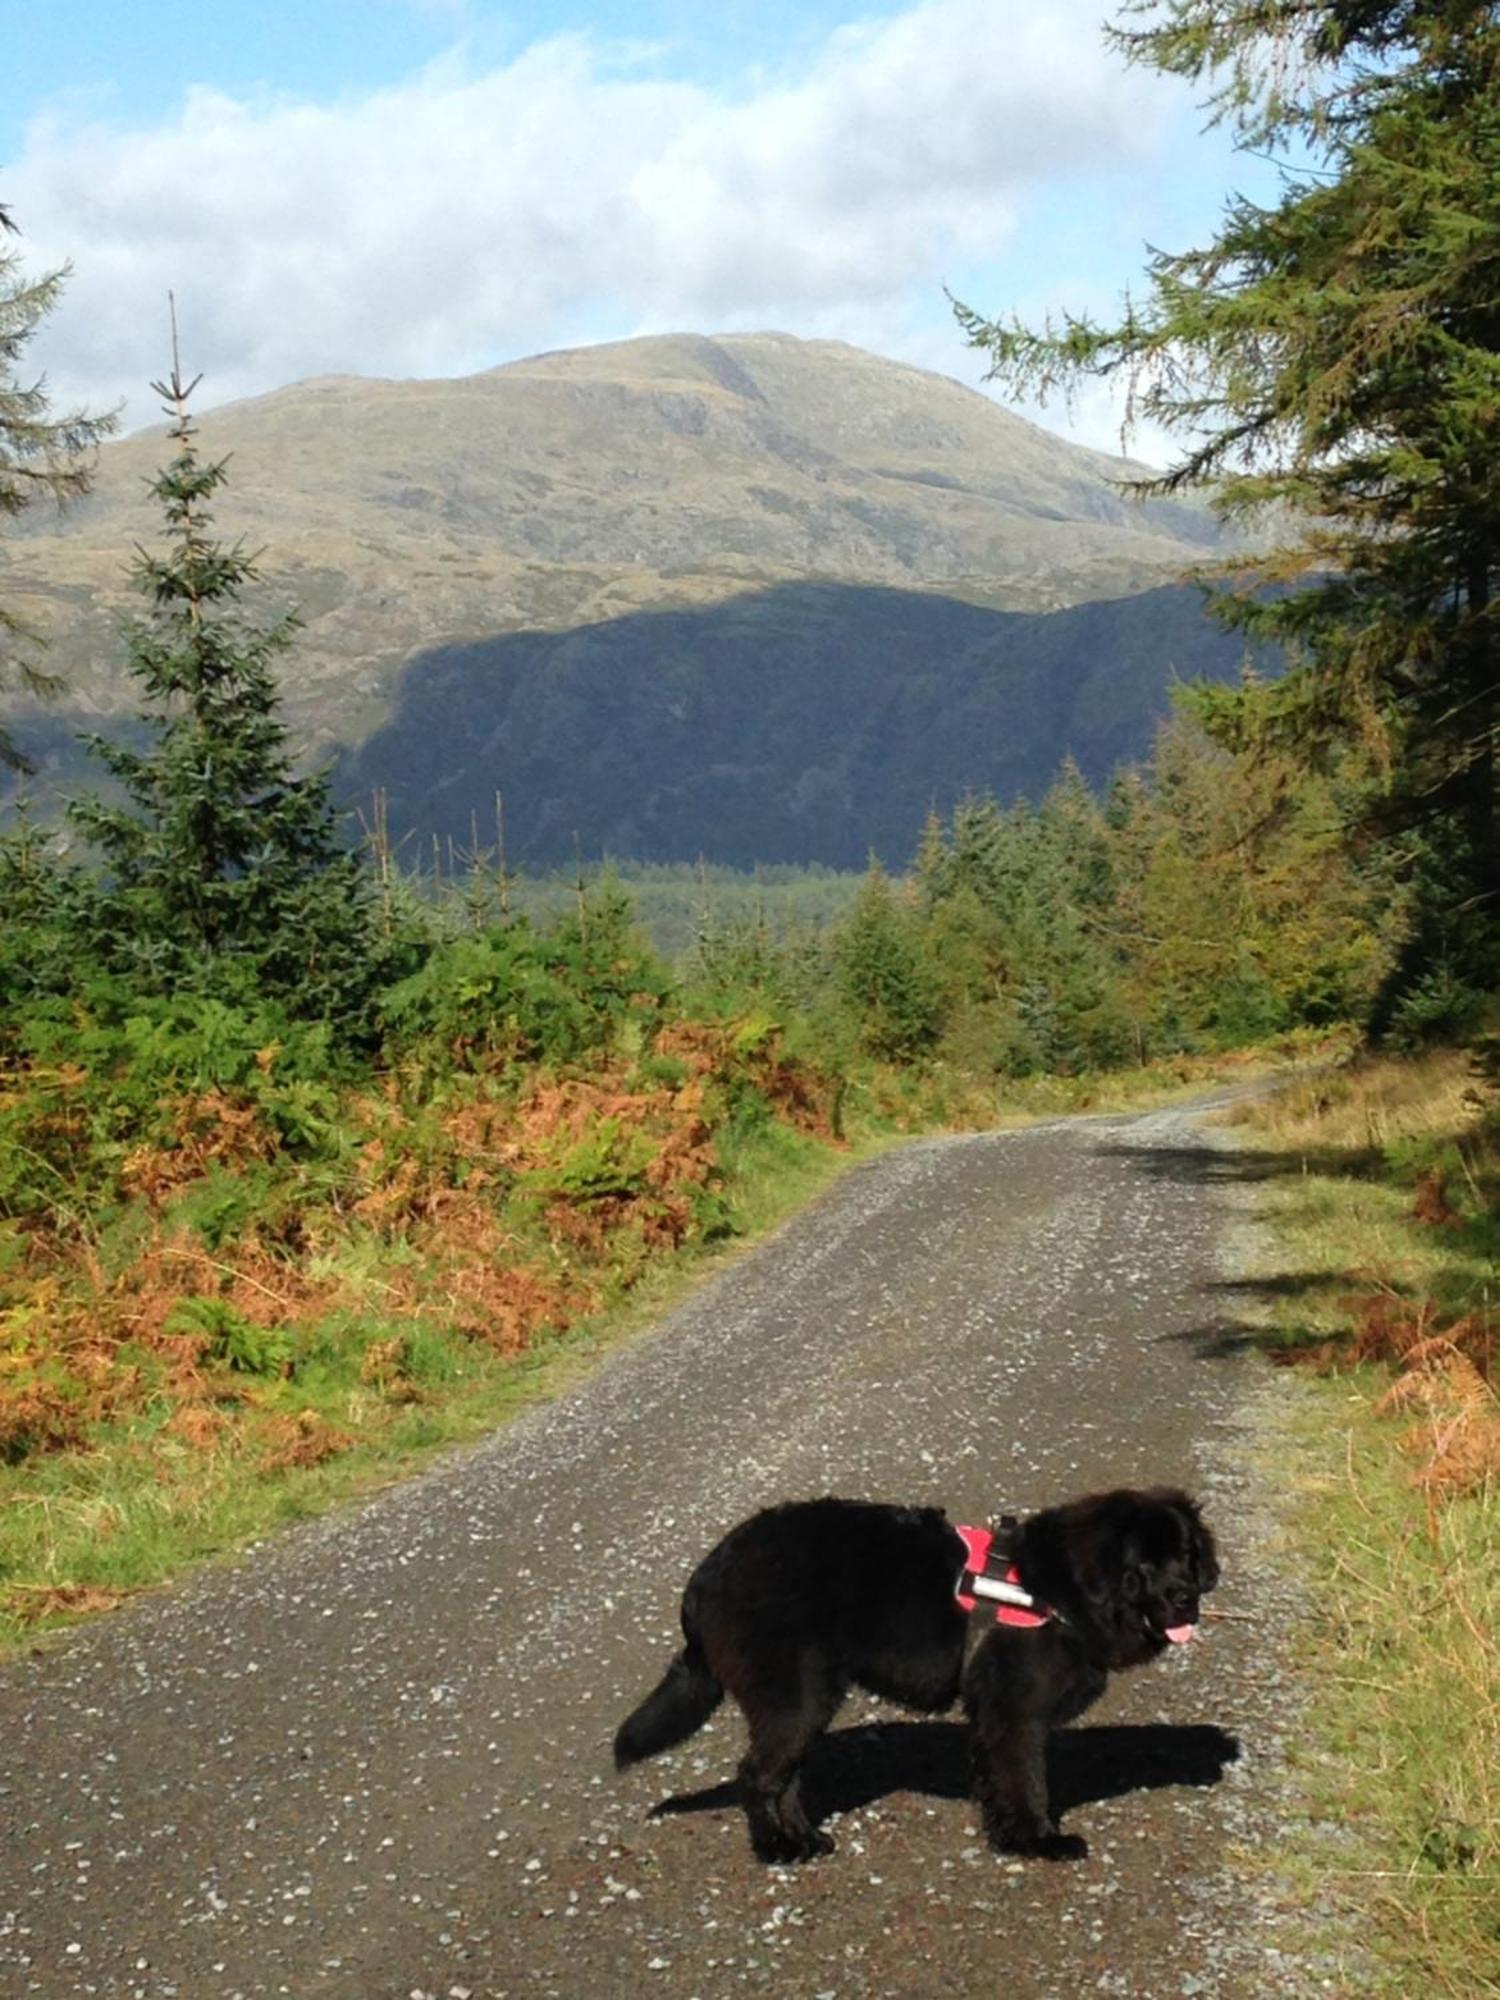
[6, 0, 1180, 442]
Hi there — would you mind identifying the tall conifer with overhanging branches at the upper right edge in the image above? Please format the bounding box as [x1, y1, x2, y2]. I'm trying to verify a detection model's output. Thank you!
[958, 0, 1500, 1000]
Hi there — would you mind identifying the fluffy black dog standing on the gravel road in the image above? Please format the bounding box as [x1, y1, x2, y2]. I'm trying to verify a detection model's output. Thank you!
[614, 1488, 1218, 1862]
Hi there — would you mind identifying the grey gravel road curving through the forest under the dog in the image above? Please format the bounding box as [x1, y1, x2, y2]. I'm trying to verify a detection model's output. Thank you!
[0, 1110, 1308, 2000]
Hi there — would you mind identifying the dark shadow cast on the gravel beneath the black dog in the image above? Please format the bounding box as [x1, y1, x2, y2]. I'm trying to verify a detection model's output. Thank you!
[650, 1722, 1240, 1824]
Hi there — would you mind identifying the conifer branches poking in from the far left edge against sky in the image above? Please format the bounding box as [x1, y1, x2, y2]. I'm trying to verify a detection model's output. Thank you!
[0, 206, 116, 770]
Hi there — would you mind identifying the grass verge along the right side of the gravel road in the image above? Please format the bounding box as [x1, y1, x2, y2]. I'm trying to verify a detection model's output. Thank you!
[1238, 1056, 1500, 2000]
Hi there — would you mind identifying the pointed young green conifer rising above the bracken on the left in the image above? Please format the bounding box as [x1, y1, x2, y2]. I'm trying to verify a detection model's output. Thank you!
[70, 334, 376, 1026]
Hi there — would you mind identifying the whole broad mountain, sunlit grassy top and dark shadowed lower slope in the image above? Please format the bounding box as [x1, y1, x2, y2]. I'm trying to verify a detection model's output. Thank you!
[0, 334, 1238, 862]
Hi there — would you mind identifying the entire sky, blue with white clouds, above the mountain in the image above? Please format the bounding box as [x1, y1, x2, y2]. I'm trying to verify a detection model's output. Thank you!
[0, 0, 1266, 456]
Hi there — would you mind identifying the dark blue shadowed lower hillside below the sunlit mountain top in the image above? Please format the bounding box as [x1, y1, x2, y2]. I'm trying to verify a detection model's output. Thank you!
[338, 584, 1264, 868]
